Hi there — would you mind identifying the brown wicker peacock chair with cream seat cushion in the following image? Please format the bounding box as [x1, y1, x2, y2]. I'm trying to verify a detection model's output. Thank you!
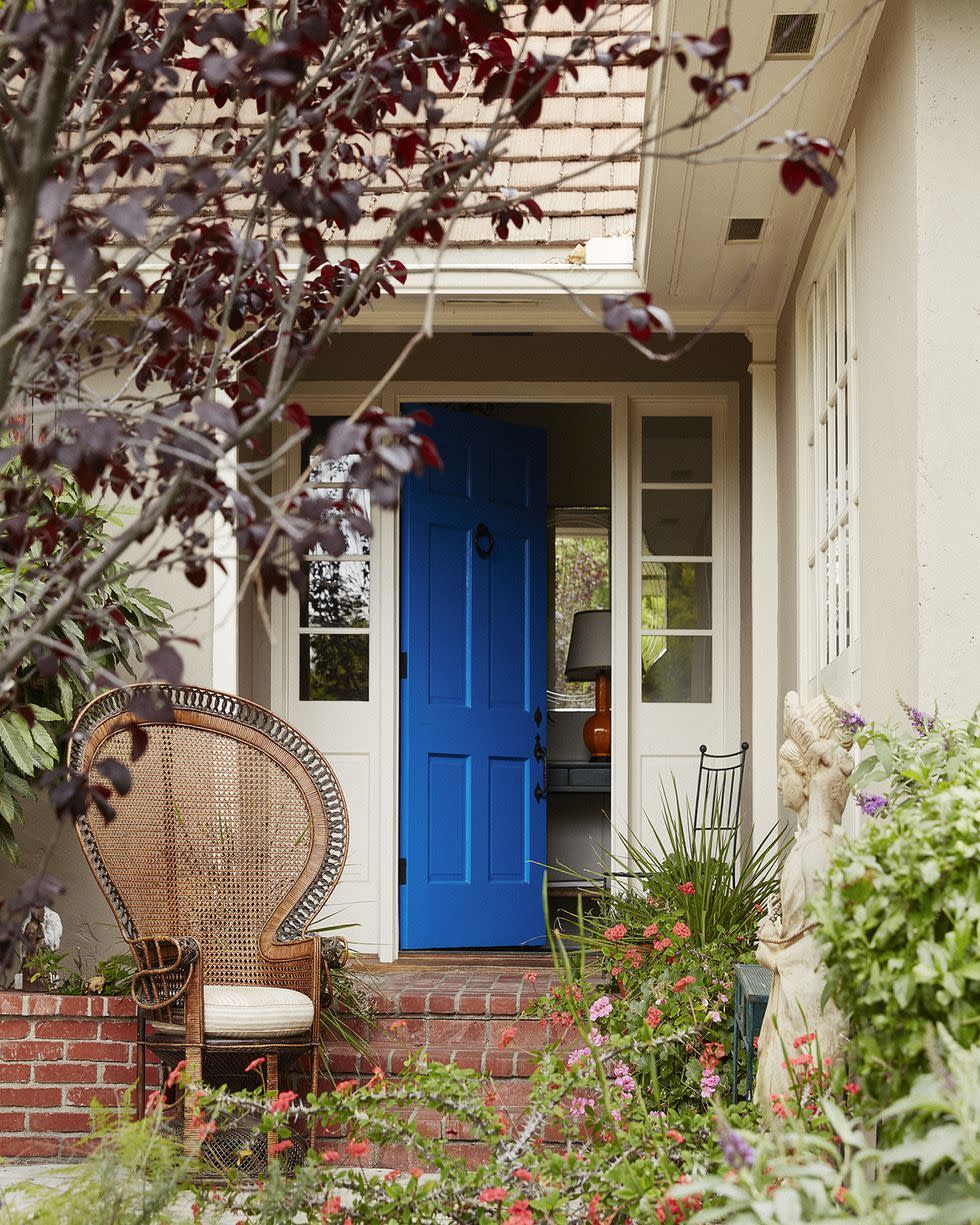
[69, 685, 348, 1166]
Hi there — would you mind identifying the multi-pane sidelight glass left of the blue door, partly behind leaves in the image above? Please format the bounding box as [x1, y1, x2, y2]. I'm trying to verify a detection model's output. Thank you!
[299, 417, 371, 702]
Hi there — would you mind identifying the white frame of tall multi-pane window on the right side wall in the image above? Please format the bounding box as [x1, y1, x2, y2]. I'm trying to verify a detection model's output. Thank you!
[795, 137, 861, 703]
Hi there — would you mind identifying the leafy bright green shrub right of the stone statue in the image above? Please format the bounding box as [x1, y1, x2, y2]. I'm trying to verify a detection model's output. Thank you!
[813, 711, 980, 1104]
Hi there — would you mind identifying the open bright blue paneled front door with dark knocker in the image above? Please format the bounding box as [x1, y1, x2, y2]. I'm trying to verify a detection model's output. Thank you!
[399, 405, 546, 948]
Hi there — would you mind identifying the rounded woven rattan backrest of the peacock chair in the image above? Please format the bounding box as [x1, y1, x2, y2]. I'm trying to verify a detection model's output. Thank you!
[71, 686, 348, 984]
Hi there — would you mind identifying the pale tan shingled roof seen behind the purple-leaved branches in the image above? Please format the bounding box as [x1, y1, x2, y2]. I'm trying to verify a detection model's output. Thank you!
[143, 0, 650, 249]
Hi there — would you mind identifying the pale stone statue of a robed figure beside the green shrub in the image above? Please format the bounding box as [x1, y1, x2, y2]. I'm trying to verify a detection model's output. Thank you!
[755, 693, 854, 1105]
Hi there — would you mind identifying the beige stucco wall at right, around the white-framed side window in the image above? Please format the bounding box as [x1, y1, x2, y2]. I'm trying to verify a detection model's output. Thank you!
[778, 0, 980, 718]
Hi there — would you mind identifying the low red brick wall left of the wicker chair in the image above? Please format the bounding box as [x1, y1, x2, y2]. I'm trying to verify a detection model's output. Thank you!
[0, 991, 154, 1159]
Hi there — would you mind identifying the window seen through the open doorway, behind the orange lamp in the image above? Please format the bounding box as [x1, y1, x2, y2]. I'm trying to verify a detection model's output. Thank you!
[548, 507, 609, 711]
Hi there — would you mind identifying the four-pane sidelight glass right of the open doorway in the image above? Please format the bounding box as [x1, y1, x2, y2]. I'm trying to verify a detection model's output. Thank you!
[639, 417, 714, 702]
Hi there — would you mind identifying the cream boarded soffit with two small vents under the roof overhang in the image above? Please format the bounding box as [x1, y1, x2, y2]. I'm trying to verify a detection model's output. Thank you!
[637, 0, 881, 327]
